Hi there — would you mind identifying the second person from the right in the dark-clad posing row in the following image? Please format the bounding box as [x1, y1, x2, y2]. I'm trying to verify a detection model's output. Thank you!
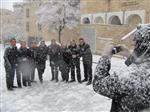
[69, 40, 81, 83]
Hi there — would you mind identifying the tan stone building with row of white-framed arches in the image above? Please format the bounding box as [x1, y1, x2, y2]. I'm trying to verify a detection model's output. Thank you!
[80, 0, 150, 53]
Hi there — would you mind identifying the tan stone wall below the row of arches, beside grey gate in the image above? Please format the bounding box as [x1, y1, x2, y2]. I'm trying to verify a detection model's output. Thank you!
[81, 24, 135, 54]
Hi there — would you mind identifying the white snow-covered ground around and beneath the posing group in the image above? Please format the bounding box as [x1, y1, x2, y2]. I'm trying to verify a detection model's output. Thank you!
[0, 46, 149, 112]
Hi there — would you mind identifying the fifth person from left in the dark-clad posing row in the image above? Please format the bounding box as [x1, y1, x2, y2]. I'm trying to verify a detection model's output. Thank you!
[48, 39, 61, 82]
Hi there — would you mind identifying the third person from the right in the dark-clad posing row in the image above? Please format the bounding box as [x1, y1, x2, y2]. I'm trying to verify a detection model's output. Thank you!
[59, 43, 71, 82]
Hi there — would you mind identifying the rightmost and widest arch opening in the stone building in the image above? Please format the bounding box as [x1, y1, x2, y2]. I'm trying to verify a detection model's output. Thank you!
[126, 14, 142, 25]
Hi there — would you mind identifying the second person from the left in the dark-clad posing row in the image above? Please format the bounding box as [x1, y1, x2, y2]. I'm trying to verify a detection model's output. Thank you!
[18, 41, 33, 86]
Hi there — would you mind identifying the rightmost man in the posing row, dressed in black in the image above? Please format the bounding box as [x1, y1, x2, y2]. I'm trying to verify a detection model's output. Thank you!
[79, 38, 92, 85]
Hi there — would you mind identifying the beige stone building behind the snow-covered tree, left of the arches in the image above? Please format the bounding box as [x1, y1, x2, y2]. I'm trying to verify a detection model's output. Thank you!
[14, 0, 80, 45]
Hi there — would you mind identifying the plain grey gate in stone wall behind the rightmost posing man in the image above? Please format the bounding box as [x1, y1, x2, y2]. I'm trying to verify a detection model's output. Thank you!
[81, 28, 96, 53]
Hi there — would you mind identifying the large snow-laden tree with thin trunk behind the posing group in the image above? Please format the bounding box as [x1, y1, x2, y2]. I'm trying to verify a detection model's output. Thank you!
[37, 0, 80, 42]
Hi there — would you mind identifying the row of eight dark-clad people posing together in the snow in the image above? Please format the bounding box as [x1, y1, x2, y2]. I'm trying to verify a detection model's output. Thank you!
[4, 38, 92, 90]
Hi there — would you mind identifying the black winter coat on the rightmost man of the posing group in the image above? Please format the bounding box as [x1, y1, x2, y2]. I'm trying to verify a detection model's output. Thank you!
[79, 43, 92, 64]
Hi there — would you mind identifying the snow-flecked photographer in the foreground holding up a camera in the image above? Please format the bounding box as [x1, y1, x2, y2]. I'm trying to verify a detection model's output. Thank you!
[93, 24, 150, 112]
